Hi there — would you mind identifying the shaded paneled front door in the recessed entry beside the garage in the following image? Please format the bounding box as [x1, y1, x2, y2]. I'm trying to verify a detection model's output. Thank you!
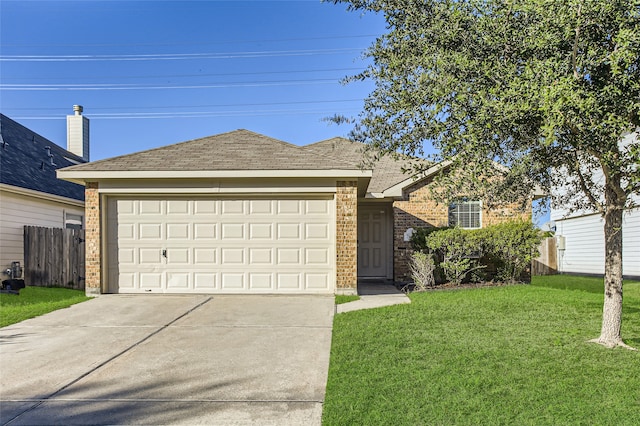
[358, 205, 391, 278]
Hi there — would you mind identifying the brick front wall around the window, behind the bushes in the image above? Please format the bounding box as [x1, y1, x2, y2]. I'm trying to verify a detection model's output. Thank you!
[393, 181, 531, 282]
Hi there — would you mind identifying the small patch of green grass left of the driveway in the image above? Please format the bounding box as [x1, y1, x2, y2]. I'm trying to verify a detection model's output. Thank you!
[0, 287, 90, 327]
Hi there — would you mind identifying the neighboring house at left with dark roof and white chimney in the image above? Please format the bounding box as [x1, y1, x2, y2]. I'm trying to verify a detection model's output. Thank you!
[0, 110, 89, 278]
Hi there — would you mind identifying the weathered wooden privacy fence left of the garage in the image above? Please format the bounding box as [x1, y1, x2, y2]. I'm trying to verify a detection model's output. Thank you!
[24, 226, 84, 290]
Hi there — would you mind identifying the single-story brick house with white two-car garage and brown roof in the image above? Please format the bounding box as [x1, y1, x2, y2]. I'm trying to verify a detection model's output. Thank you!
[58, 130, 530, 294]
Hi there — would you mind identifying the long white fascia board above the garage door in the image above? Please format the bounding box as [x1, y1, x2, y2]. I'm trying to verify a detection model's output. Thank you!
[57, 169, 372, 184]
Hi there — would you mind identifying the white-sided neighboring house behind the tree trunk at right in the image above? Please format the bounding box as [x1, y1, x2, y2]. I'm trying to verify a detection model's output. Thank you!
[550, 133, 640, 279]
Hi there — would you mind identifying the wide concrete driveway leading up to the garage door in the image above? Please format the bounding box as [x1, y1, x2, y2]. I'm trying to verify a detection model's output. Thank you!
[0, 295, 334, 425]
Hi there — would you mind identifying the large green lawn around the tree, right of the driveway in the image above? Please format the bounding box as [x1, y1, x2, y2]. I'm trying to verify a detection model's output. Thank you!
[323, 276, 640, 425]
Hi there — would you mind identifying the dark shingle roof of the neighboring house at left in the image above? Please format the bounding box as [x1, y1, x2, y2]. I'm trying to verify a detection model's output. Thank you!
[0, 114, 84, 201]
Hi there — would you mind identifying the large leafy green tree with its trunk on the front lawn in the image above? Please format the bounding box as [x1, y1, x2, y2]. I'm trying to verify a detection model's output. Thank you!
[333, 0, 640, 347]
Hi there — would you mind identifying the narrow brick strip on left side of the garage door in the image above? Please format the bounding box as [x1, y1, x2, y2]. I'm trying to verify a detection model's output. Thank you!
[84, 182, 102, 296]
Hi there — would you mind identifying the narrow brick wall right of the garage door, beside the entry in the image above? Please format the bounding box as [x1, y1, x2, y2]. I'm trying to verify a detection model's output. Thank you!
[336, 181, 358, 294]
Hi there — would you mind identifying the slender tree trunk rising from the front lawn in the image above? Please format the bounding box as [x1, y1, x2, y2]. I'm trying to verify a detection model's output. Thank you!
[591, 183, 633, 349]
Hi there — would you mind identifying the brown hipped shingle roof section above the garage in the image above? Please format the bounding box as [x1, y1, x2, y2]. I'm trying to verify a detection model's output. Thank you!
[63, 129, 359, 172]
